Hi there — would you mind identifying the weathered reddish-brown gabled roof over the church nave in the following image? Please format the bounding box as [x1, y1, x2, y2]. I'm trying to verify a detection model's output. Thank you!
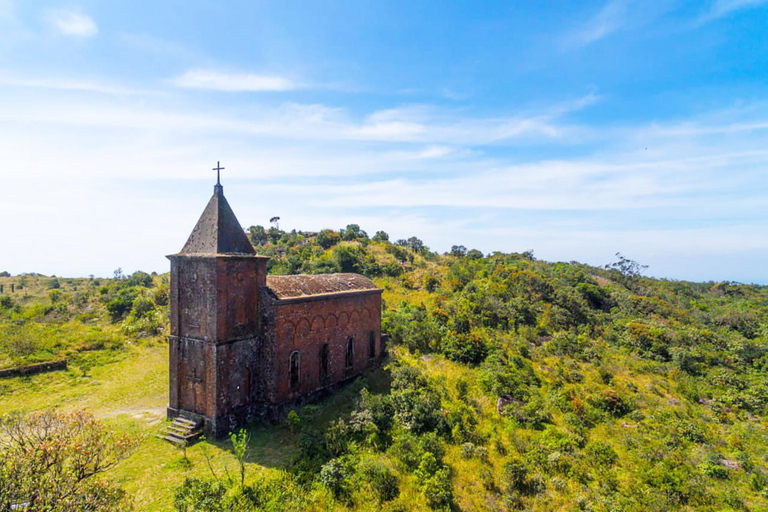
[267, 274, 378, 299]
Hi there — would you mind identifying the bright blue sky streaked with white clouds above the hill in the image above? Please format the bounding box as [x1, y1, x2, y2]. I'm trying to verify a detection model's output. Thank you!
[0, 0, 768, 283]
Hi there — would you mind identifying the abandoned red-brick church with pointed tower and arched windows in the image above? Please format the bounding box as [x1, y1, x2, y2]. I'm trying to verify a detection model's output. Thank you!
[168, 175, 384, 437]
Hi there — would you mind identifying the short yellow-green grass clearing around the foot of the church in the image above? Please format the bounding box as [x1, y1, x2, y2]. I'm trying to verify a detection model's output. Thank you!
[0, 345, 388, 512]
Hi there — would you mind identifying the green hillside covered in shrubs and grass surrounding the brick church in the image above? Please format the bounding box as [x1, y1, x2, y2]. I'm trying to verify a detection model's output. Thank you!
[0, 226, 768, 511]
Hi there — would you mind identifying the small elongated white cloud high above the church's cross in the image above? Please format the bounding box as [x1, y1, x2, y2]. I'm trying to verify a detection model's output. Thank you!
[173, 69, 300, 92]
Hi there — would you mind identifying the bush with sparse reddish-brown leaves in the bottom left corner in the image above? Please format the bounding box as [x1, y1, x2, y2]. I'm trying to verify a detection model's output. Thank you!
[0, 411, 137, 512]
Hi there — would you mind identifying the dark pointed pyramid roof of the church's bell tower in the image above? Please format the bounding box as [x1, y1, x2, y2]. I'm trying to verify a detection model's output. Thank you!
[179, 183, 255, 254]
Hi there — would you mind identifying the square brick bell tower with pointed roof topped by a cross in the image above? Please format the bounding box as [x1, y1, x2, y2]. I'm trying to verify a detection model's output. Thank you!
[168, 170, 269, 435]
